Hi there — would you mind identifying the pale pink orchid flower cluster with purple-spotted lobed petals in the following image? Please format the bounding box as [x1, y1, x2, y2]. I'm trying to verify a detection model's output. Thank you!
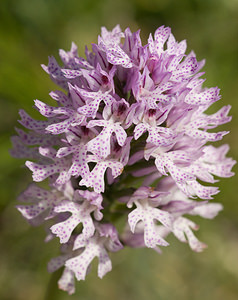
[11, 25, 235, 294]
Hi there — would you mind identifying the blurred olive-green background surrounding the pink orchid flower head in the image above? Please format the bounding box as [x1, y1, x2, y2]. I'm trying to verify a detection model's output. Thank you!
[0, 0, 238, 300]
